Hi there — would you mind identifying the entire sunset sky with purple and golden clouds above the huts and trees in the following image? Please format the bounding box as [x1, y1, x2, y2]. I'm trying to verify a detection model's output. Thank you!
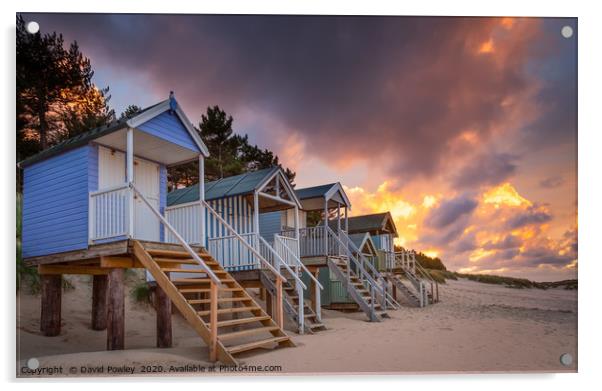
[24, 14, 577, 281]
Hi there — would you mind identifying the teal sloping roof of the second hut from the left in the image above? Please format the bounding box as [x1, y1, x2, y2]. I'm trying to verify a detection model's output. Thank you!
[167, 167, 298, 210]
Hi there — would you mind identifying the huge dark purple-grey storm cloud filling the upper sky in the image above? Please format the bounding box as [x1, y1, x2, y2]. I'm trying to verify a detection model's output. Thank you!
[21, 14, 568, 184]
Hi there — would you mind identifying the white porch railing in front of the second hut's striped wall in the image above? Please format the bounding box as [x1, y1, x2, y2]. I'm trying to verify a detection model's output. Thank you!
[207, 232, 260, 271]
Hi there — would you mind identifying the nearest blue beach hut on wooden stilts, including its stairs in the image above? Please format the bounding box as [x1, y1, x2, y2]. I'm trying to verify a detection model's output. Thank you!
[19, 94, 294, 363]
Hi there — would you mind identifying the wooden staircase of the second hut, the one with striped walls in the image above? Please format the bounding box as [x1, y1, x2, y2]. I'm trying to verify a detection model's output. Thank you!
[260, 269, 326, 334]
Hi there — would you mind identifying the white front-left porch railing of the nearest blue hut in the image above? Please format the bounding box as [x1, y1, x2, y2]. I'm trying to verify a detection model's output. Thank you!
[88, 183, 131, 241]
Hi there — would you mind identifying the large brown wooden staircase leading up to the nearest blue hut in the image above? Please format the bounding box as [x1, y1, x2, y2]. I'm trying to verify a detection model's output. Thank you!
[133, 241, 295, 365]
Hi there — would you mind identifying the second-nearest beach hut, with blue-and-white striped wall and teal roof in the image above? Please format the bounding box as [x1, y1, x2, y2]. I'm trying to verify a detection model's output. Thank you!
[166, 167, 324, 333]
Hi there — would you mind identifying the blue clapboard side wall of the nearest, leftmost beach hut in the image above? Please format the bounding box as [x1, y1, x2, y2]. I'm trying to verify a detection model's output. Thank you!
[23, 145, 92, 258]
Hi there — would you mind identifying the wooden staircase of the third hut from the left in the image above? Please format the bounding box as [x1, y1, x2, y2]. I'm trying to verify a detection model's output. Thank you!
[328, 256, 389, 322]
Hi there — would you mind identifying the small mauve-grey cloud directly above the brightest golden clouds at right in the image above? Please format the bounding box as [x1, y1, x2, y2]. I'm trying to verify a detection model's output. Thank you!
[452, 153, 517, 188]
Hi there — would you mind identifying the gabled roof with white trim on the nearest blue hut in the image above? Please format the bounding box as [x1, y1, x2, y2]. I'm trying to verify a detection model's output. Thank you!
[19, 98, 209, 167]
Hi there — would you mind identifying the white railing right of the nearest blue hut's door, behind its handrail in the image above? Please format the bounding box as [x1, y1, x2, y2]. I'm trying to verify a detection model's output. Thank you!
[165, 202, 202, 244]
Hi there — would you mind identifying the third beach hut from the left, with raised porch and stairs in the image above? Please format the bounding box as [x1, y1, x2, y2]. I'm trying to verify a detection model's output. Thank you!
[260, 182, 397, 321]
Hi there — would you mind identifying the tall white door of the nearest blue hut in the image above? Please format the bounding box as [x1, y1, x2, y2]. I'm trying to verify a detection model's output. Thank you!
[134, 159, 160, 242]
